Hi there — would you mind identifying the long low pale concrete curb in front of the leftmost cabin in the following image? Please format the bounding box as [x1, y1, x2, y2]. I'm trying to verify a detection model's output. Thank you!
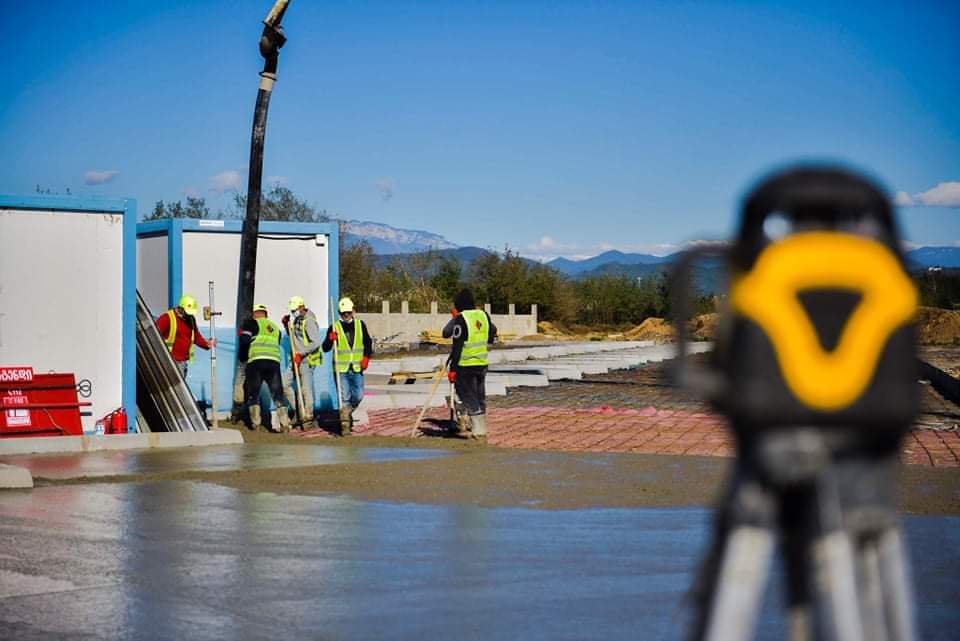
[0, 430, 243, 456]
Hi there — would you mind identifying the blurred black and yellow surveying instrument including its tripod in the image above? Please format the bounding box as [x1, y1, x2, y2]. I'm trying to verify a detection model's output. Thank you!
[674, 167, 919, 641]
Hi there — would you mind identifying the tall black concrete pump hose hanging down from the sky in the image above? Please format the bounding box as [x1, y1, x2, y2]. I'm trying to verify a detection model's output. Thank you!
[234, 0, 290, 410]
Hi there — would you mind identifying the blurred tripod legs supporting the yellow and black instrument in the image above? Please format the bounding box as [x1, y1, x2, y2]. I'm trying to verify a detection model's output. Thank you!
[691, 428, 916, 641]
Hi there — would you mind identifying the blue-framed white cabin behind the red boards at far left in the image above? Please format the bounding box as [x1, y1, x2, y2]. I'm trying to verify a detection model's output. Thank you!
[0, 195, 137, 432]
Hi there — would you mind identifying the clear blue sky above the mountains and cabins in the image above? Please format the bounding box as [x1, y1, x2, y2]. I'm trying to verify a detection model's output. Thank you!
[0, 0, 960, 256]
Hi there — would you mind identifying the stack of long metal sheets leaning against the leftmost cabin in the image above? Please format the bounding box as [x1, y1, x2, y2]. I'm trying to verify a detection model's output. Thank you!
[137, 291, 209, 432]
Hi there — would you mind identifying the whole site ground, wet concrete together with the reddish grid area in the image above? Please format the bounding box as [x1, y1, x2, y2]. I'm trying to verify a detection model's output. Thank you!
[0, 353, 960, 641]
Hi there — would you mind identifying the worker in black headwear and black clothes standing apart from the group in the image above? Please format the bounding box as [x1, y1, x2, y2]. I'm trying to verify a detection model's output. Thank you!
[443, 289, 497, 440]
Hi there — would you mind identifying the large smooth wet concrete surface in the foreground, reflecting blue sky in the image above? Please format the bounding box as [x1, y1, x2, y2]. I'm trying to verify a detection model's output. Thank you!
[0, 481, 960, 641]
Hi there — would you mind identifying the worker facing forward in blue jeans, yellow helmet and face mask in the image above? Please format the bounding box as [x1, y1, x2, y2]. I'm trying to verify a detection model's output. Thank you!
[323, 298, 373, 436]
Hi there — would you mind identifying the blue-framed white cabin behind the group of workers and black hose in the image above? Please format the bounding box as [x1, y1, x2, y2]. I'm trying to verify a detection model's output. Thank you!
[137, 218, 339, 413]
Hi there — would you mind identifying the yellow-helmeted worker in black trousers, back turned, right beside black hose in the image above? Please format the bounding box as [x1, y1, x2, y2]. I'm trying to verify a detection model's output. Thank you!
[237, 305, 290, 432]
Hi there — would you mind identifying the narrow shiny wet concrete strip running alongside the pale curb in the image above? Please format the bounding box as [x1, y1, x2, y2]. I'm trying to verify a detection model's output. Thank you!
[0, 443, 447, 480]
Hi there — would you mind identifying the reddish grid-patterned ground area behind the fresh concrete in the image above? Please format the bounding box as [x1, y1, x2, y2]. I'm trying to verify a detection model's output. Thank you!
[298, 364, 960, 467]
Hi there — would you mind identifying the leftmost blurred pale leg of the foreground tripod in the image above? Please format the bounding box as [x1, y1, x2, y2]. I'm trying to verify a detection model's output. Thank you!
[699, 526, 773, 641]
